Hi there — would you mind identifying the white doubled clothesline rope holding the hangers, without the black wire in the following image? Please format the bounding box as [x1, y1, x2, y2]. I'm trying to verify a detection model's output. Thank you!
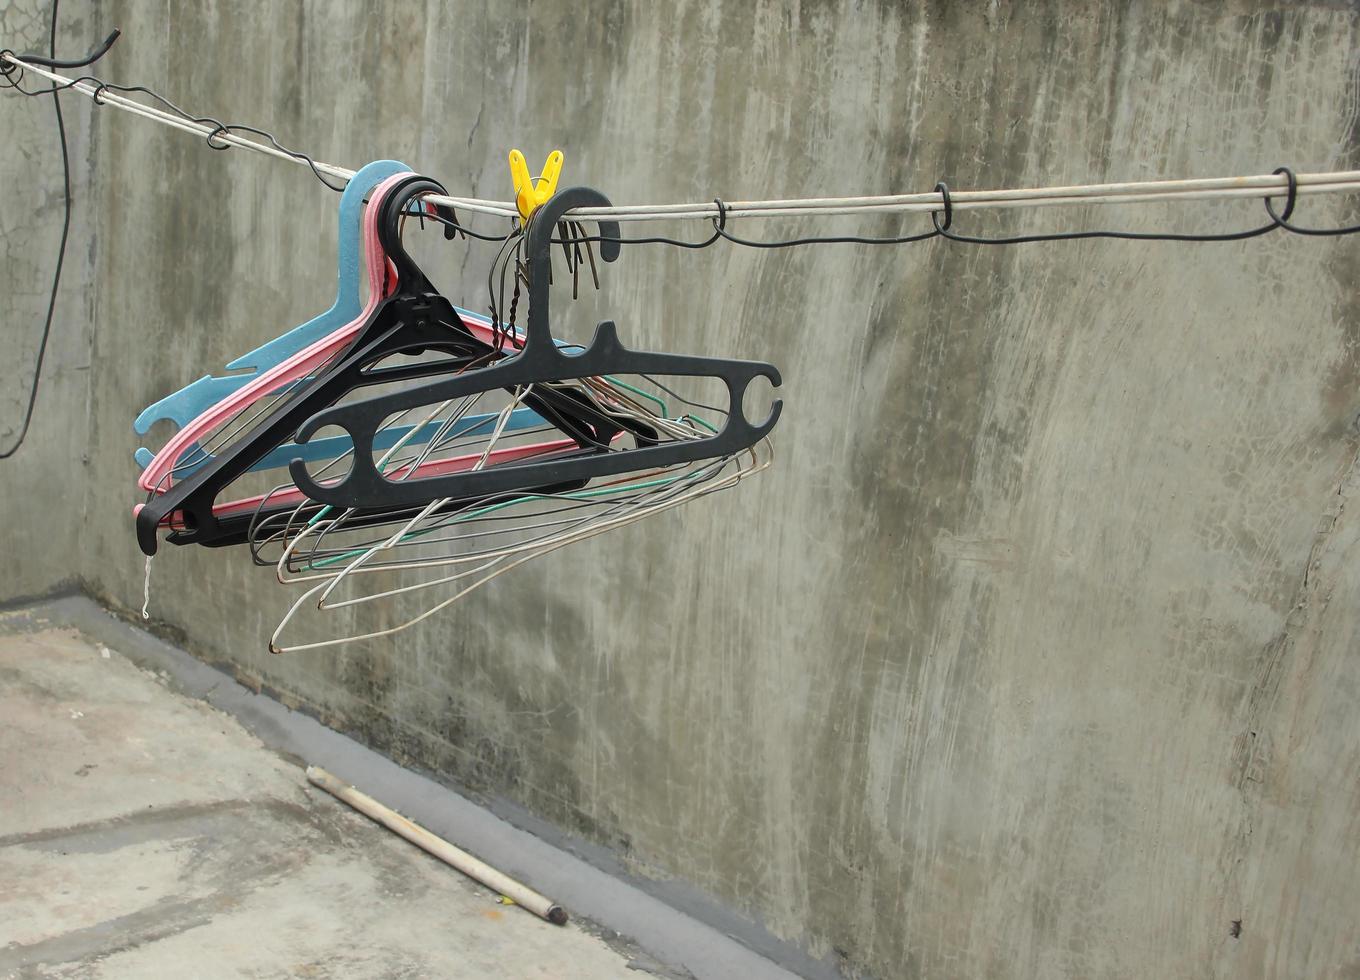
[0, 52, 1360, 222]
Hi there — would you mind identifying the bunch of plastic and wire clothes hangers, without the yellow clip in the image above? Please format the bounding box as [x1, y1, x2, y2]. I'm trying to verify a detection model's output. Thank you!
[135, 160, 781, 652]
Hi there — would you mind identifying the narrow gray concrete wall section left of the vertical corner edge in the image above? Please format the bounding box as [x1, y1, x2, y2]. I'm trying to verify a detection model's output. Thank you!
[0, 0, 99, 598]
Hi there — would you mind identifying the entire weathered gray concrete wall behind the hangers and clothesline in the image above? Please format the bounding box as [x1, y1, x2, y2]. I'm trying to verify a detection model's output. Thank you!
[0, 0, 1360, 977]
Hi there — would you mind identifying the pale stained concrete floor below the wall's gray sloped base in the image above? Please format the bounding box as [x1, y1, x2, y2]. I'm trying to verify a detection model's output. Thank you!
[0, 628, 639, 979]
